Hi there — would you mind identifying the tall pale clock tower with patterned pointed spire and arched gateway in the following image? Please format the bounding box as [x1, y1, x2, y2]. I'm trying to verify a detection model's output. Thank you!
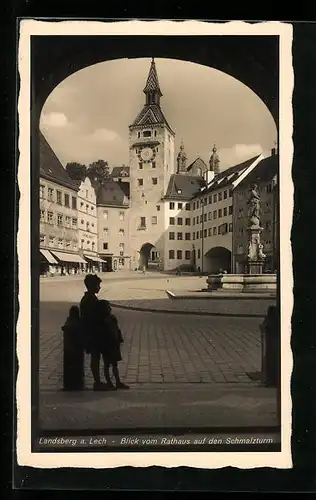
[129, 59, 175, 269]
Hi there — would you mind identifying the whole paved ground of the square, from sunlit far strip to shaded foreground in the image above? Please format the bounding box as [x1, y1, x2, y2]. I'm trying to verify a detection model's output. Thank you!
[39, 273, 276, 429]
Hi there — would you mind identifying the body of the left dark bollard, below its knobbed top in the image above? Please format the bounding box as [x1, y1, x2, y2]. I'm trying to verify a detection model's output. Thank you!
[63, 329, 84, 391]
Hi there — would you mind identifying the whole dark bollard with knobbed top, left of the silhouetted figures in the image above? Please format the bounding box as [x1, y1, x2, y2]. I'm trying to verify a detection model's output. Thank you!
[62, 306, 84, 391]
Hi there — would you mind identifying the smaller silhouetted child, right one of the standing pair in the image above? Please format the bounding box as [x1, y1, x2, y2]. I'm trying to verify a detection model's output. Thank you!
[98, 300, 129, 390]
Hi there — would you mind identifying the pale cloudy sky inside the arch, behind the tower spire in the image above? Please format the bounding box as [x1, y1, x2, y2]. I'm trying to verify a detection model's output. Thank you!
[40, 58, 277, 170]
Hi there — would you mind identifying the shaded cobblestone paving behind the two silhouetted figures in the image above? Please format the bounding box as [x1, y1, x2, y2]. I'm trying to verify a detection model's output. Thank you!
[40, 302, 261, 389]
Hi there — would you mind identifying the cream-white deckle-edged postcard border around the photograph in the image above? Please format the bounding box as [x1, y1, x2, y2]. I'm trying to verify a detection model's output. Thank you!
[16, 19, 294, 469]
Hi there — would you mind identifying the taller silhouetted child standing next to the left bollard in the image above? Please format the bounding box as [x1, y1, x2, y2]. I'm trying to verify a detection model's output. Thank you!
[80, 274, 106, 391]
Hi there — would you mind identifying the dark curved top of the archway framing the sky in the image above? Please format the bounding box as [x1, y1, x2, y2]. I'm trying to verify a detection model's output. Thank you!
[31, 35, 279, 126]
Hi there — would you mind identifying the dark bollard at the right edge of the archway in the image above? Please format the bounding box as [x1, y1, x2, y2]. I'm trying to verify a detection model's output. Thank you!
[260, 306, 280, 387]
